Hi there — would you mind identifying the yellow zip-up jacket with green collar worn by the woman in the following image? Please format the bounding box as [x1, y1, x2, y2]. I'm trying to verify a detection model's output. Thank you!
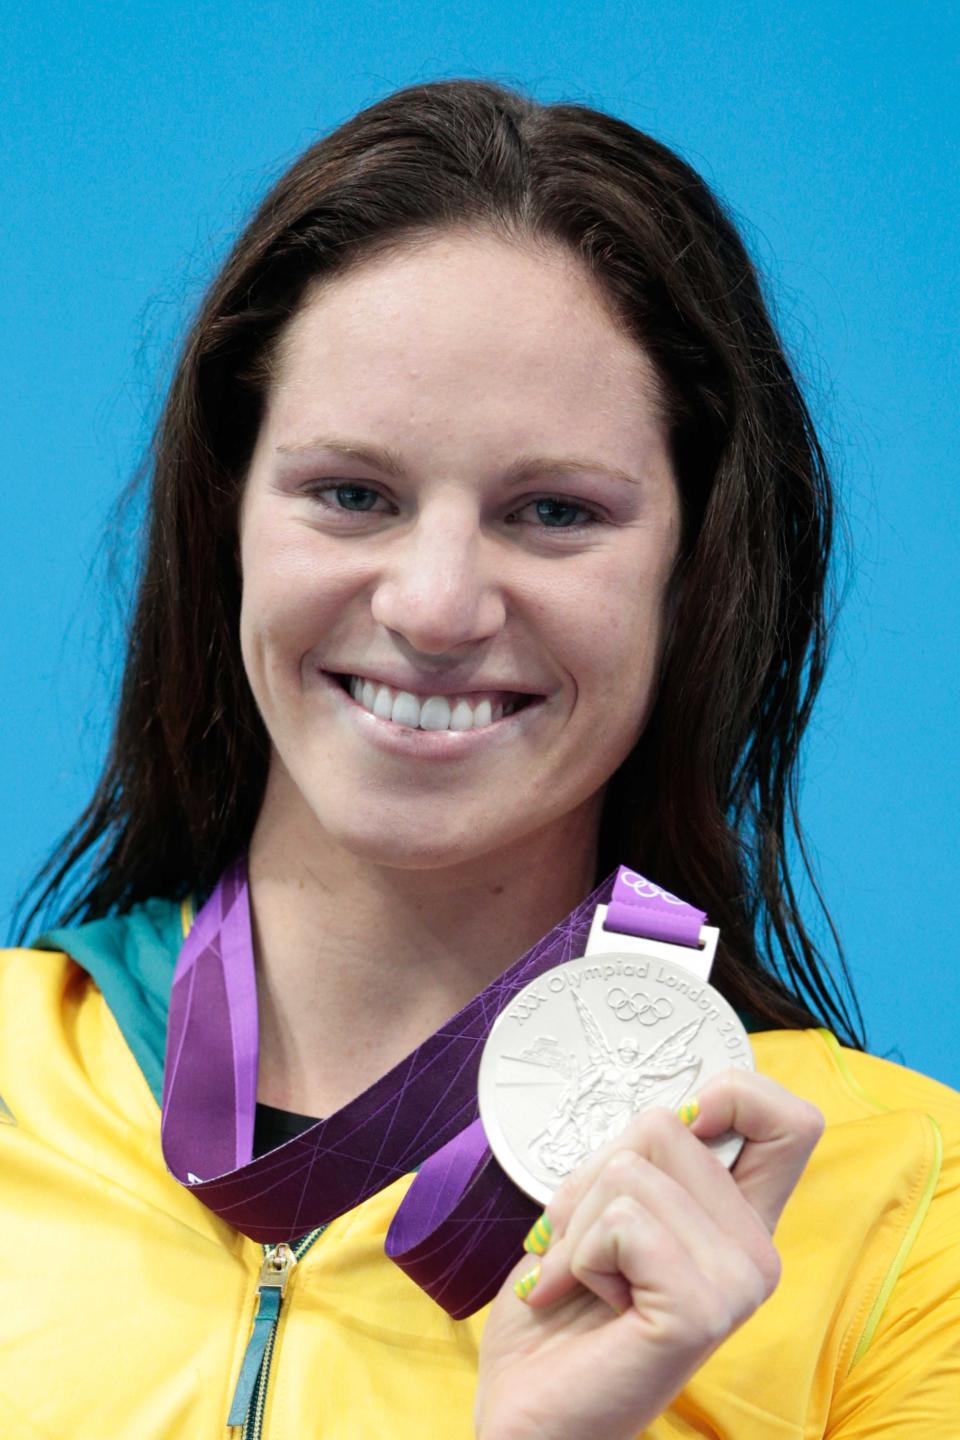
[0, 901, 960, 1440]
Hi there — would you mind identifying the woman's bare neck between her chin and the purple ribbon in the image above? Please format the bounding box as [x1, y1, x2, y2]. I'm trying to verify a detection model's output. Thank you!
[249, 815, 596, 1116]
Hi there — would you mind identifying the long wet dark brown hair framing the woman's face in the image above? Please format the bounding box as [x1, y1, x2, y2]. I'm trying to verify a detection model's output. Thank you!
[15, 81, 862, 1044]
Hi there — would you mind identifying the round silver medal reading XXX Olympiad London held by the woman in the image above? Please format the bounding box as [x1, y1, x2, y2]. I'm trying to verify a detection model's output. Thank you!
[479, 952, 754, 1205]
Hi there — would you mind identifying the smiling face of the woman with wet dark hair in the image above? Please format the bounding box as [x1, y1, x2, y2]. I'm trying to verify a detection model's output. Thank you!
[240, 233, 679, 868]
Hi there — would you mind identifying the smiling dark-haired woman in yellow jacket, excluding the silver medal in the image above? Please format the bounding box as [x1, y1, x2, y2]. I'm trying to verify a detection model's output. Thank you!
[0, 82, 960, 1440]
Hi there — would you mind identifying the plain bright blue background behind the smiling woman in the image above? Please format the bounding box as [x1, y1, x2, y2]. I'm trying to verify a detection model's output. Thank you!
[0, 0, 960, 1084]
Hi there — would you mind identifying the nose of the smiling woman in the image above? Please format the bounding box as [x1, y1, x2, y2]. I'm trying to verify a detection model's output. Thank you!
[371, 513, 507, 655]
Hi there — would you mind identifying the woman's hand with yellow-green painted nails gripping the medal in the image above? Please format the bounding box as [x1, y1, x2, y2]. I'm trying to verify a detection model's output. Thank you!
[475, 1070, 823, 1440]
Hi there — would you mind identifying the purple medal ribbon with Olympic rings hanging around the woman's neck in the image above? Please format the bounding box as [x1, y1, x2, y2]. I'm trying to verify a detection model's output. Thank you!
[161, 858, 705, 1319]
